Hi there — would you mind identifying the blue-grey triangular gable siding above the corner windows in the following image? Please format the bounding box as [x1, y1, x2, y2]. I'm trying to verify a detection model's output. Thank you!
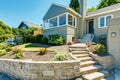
[43, 4, 67, 20]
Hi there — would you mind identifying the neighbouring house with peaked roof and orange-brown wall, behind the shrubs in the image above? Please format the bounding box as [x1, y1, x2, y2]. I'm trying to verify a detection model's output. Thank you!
[18, 21, 43, 35]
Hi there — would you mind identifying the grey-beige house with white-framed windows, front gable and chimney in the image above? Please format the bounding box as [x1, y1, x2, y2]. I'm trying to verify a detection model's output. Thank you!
[43, 0, 120, 42]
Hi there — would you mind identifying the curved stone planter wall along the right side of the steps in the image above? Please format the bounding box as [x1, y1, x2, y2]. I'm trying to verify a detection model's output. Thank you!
[89, 52, 114, 70]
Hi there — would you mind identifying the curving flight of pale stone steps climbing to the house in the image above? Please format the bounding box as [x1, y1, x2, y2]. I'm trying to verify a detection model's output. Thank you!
[69, 44, 109, 80]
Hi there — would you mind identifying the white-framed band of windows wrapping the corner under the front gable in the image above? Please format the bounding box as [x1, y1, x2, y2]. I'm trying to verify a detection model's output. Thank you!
[44, 13, 76, 29]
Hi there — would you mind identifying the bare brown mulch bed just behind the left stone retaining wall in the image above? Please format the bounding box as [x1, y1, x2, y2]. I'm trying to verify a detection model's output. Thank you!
[0, 51, 56, 61]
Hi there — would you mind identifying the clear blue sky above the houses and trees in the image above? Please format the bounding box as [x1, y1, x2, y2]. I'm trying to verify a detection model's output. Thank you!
[0, 0, 100, 27]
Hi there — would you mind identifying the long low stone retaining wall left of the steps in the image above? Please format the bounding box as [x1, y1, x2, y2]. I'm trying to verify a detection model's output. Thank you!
[0, 59, 80, 80]
